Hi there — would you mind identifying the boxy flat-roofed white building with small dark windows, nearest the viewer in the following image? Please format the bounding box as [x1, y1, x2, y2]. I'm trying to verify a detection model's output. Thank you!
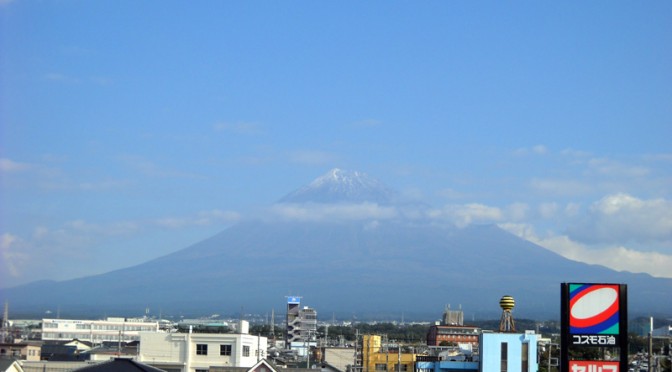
[138, 325, 268, 372]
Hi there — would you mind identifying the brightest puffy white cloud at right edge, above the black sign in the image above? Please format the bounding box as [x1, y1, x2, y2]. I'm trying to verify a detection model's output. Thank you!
[568, 193, 672, 244]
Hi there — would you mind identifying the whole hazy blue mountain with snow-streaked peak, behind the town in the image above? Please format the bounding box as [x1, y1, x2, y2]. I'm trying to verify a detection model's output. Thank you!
[2, 169, 672, 318]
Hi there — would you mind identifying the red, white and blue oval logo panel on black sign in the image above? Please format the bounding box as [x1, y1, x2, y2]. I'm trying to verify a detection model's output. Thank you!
[569, 284, 619, 335]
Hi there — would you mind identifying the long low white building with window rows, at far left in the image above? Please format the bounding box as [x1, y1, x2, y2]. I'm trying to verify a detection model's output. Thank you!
[42, 318, 159, 344]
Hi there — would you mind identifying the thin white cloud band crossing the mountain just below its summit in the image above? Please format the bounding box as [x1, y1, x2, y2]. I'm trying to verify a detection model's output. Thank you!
[271, 203, 398, 222]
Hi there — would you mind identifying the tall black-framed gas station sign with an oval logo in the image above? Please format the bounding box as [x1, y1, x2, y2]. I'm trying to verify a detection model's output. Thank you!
[560, 283, 628, 372]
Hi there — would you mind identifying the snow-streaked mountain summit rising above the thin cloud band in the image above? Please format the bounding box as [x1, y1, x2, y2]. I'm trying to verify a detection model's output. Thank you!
[280, 168, 395, 204]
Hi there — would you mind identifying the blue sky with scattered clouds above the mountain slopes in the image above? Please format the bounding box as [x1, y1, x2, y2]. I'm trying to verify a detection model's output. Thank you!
[0, 0, 672, 287]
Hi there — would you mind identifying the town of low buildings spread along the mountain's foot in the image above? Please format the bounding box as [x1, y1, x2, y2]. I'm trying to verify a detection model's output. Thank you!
[0, 296, 672, 372]
